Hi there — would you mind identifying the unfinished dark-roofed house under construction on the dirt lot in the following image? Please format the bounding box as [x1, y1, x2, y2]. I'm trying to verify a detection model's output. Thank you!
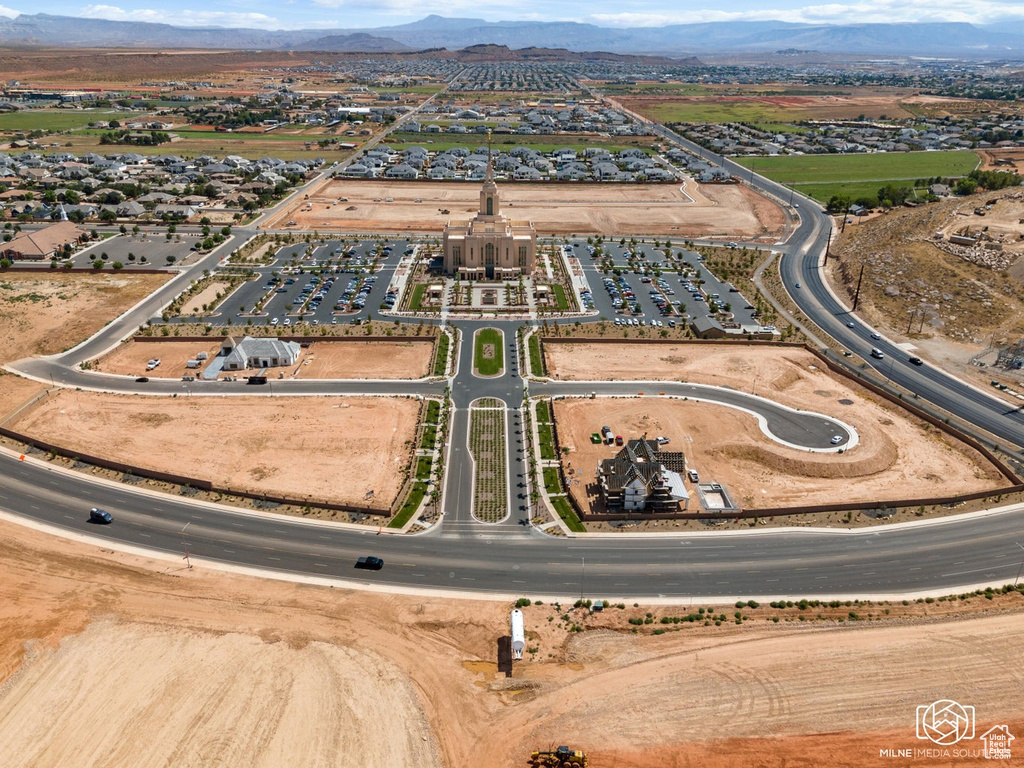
[597, 438, 690, 512]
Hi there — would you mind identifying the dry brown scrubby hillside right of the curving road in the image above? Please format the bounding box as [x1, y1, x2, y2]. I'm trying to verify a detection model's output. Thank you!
[826, 188, 1024, 372]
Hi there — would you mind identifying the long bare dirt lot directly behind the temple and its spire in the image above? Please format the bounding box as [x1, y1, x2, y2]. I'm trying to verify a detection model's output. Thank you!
[265, 180, 784, 238]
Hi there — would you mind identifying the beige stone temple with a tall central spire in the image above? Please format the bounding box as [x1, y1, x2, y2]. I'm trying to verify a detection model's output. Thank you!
[444, 140, 537, 280]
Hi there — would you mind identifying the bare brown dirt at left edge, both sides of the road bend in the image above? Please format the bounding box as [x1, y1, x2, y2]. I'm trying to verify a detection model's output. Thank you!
[0, 272, 170, 415]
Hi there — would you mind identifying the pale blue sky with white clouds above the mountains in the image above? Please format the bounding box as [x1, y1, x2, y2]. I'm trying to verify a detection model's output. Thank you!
[6, 0, 1024, 30]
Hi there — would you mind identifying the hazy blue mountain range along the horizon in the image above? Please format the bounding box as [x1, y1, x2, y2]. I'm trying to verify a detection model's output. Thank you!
[0, 13, 1024, 58]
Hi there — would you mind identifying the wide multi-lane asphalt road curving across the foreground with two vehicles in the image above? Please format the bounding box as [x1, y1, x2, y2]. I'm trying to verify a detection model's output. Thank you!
[0, 455, 1024, 602]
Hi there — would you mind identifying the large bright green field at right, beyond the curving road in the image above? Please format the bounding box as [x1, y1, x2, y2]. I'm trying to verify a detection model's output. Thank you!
[736, 150, 980, 203]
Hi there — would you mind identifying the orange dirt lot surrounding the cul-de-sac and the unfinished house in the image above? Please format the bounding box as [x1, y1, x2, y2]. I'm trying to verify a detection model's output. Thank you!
[546, 344, 1006, 510]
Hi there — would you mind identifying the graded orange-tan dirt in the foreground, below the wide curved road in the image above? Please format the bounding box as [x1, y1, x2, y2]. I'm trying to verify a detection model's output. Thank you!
[0, 526, 1024, 768]
